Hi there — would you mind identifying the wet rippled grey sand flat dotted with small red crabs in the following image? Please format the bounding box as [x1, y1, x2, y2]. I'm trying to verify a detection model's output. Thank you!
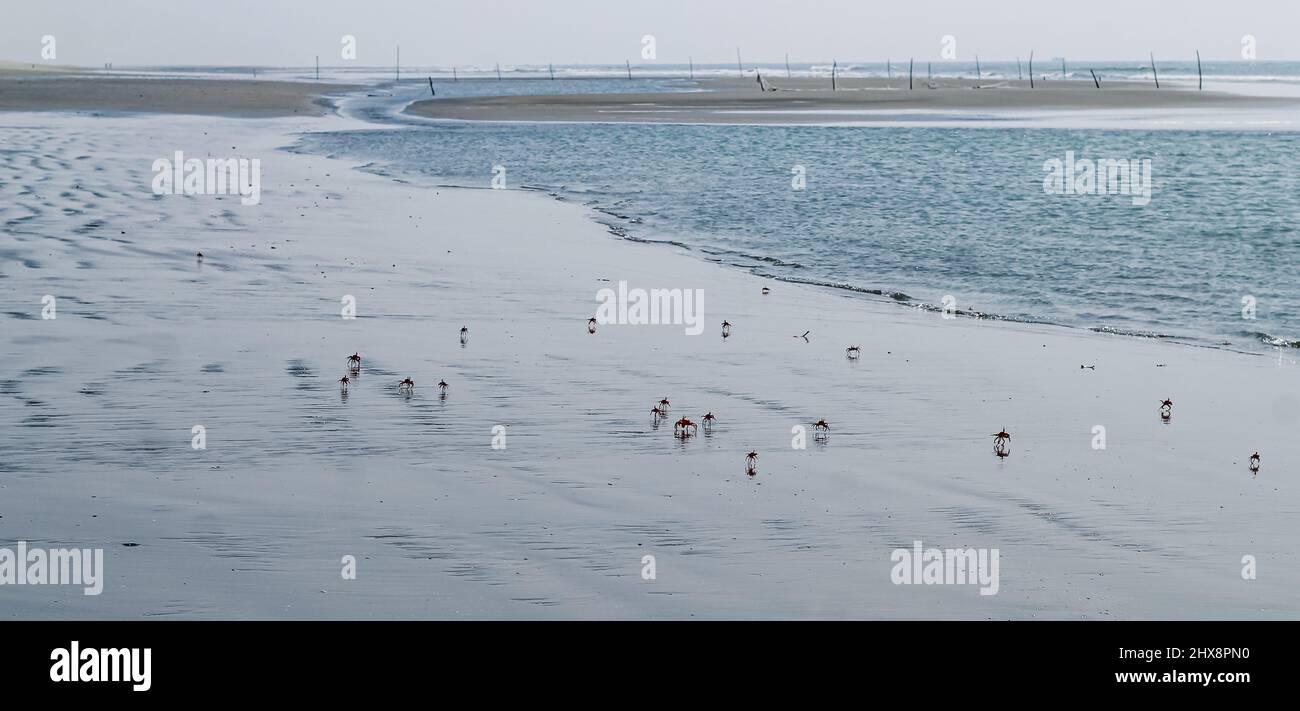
[0, 114, 1300, 619]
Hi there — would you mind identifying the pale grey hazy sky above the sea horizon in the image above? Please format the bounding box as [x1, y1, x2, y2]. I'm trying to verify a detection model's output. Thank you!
[0, 0, 1300, 66]
